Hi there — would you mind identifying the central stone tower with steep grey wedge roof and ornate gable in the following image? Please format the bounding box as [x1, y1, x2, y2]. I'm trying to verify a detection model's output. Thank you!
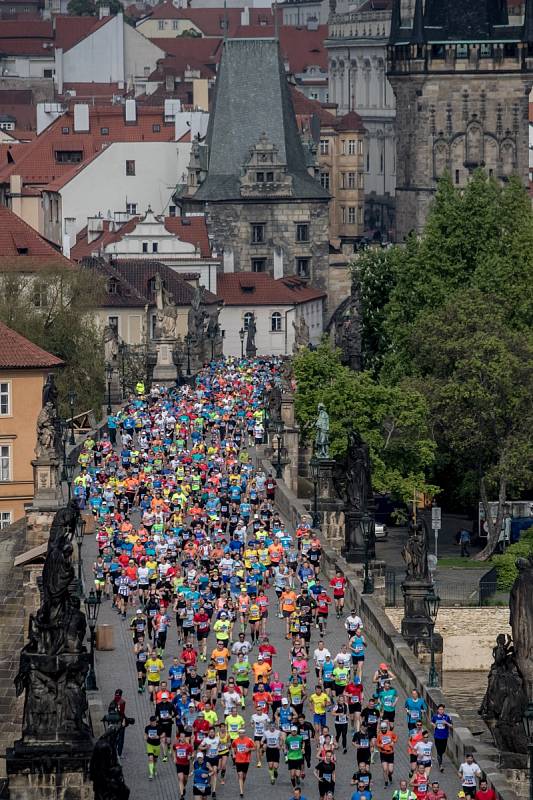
[180, 39, 330, 296]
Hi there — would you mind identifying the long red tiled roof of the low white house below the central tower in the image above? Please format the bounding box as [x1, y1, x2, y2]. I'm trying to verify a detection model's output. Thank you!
[217, 272, 326, 306]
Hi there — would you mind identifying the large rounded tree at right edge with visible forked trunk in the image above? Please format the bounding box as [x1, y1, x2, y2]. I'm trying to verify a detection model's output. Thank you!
[409, 288, 533, 560]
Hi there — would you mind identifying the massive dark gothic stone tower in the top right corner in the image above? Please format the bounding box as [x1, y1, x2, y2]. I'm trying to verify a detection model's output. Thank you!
[387, 0, 533, 242]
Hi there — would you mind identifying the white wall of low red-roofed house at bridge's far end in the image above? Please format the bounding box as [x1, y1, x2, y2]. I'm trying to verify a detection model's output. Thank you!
[219, 300, 323, 357]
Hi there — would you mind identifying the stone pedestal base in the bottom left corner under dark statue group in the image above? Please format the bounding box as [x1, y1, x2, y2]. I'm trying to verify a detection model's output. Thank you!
[6, 742, 94, 800]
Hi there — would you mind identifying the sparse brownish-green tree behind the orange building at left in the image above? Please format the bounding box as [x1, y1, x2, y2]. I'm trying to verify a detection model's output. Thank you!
[0, 268, 104, 416]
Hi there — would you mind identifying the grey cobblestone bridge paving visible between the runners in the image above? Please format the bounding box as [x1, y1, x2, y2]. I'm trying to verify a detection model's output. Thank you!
[84, 537, 460, 800]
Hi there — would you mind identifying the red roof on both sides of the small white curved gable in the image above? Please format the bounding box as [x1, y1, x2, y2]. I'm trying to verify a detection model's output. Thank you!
[70, 212, 211, 261]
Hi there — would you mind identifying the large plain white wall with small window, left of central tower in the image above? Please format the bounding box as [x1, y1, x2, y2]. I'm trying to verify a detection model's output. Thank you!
[45, 142, 191, 244]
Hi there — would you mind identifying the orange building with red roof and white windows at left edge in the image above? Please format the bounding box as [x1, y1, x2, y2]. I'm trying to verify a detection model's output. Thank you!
[0, 322, 63, 528]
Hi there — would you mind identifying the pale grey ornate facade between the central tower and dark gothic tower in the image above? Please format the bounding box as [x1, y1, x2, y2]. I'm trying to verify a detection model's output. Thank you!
[325, 0, 396, 238]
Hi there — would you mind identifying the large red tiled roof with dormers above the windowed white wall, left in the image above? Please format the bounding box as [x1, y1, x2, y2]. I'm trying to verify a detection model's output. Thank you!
[0, 105, 175, 186]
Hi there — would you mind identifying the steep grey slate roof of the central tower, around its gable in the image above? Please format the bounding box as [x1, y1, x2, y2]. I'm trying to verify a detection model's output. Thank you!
[194, 38, 328, 201]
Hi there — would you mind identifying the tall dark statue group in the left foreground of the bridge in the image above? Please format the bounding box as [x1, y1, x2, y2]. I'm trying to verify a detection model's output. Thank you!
[15, 501, 91, 744]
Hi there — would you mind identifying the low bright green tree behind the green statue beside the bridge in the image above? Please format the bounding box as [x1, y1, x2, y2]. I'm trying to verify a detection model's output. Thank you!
[293, 343, 436, 500]
